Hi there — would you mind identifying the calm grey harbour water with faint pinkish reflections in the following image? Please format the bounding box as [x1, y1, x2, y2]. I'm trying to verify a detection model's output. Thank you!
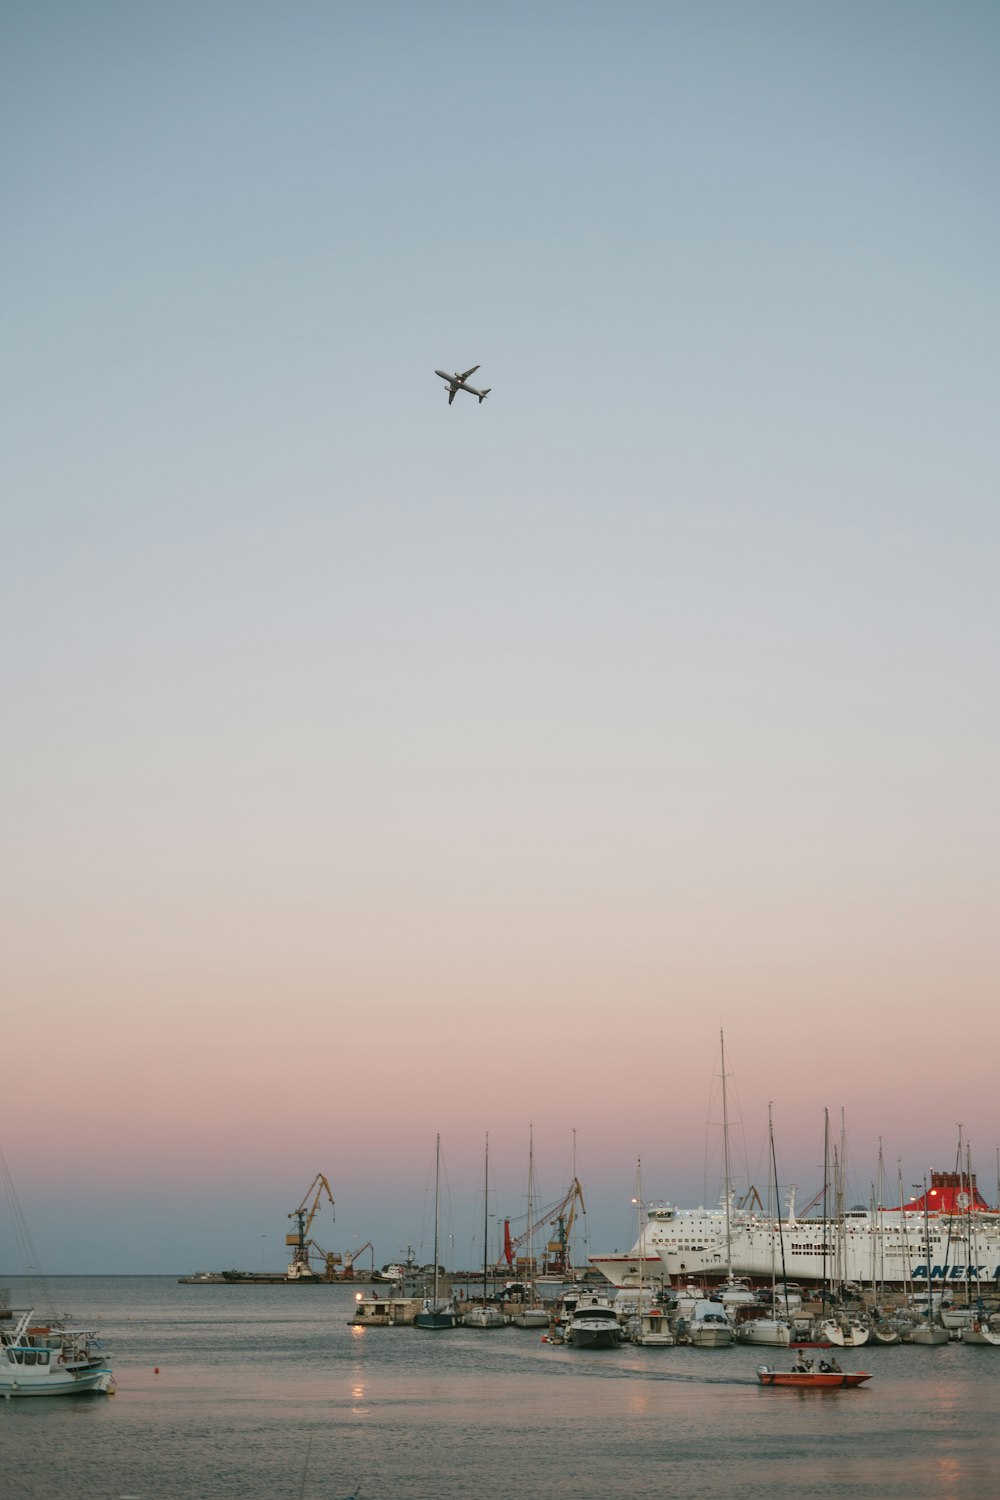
[0, 1277, 1000, 1500]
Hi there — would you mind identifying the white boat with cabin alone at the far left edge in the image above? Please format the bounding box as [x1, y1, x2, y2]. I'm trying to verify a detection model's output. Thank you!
[0, 1308, 114, 1397]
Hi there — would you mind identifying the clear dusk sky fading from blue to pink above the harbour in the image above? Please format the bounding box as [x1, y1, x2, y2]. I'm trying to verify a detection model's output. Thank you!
[0, 0, 1000, 1275]
